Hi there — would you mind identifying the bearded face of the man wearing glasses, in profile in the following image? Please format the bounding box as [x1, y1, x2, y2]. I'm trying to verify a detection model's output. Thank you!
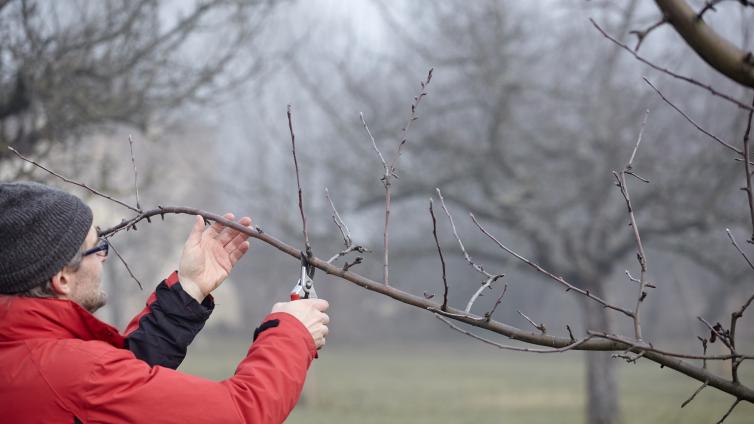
[68, 226, 107, 312]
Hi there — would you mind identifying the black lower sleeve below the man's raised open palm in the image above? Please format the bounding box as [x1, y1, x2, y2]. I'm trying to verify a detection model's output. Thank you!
[125, 272, 215, 369]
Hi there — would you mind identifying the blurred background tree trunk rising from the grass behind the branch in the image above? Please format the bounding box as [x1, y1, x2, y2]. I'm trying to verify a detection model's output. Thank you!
[583, 294, 621, 424]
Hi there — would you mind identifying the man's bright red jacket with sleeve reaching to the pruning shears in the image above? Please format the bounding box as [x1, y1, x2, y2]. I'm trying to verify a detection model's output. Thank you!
[0, 288, 316, 424]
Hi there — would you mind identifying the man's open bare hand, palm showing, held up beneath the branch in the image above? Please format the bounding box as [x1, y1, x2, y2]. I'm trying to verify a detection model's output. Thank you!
[178, 213, 251, 303]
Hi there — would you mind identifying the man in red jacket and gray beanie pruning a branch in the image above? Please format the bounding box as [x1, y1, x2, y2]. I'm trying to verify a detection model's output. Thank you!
[0, 182, 329, 423]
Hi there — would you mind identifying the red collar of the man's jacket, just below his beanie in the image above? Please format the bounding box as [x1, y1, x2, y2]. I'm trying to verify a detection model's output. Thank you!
[0, 295, 124, 348]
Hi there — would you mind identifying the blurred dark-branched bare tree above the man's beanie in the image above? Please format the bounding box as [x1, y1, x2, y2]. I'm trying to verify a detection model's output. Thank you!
[0, 0, 273, 178]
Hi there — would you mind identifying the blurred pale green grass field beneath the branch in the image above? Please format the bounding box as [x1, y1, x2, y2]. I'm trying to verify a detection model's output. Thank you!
[181, 343, 754, 424]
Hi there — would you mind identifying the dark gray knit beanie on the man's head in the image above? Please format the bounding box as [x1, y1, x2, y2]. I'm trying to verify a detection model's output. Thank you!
[0, 182, 92, 294]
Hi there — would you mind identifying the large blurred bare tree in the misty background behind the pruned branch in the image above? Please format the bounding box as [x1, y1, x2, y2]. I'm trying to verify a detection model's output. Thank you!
[286, 1, 747, 423]
